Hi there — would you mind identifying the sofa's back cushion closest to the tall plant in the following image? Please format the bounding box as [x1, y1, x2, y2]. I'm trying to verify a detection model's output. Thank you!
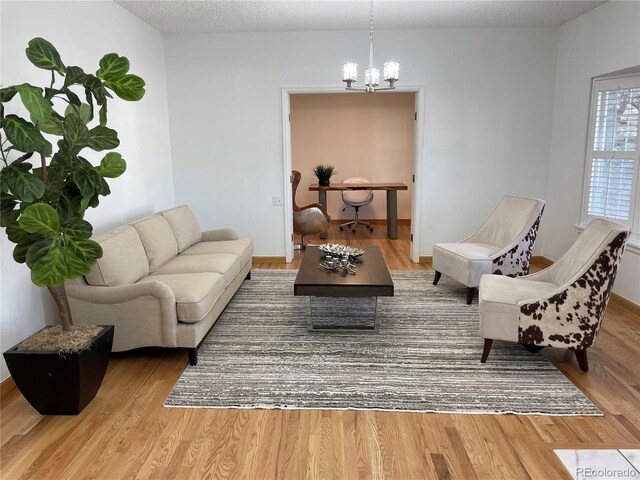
[85, 225, 149, 287]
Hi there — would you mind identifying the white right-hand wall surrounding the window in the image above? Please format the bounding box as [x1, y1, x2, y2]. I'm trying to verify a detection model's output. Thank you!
[544, 2, 640, 303]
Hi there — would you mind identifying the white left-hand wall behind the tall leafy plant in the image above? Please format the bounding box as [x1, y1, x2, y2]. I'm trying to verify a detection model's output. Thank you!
[0, 2, 173, 380]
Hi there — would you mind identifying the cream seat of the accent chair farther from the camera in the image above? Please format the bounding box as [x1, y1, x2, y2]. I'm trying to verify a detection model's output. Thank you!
[433, 242, 500, 287]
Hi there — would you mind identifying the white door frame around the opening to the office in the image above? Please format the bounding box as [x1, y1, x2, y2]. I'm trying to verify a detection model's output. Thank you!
[282, 85, 426, 263]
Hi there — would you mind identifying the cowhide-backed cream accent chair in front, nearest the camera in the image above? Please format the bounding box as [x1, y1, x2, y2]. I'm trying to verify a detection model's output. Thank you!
[479, 220, 629, 372]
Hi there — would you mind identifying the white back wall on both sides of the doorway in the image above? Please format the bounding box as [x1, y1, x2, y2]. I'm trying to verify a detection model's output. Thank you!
[165, 28, 557, 256]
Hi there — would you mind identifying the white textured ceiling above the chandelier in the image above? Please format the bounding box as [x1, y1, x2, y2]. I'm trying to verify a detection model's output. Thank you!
[114, 0, 605, 33]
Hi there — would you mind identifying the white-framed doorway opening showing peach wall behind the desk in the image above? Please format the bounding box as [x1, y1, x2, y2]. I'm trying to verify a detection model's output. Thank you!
[283, 87, 424, 262]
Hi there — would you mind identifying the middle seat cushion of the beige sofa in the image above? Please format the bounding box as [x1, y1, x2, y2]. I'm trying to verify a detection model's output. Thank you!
[152, 253, 243, 287]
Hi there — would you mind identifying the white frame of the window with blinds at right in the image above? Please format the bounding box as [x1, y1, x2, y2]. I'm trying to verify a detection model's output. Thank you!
[580, 71, 640, 240]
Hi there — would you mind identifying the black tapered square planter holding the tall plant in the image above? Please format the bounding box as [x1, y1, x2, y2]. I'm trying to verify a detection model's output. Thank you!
[4, 325, 113, 415]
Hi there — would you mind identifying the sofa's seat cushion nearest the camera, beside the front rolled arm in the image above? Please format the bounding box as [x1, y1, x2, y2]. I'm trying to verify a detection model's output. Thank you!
[138, 273, 224, 323]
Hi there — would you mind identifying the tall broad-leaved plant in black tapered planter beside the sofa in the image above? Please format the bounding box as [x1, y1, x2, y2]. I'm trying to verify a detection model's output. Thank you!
[0, 38, 145, 415]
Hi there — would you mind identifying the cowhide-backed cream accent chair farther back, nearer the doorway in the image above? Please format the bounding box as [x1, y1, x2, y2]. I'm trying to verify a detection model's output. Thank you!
[433, 195, 544, 304]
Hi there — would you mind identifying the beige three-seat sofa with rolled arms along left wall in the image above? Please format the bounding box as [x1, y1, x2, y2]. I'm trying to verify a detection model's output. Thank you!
[65, 205, 253, 365]
